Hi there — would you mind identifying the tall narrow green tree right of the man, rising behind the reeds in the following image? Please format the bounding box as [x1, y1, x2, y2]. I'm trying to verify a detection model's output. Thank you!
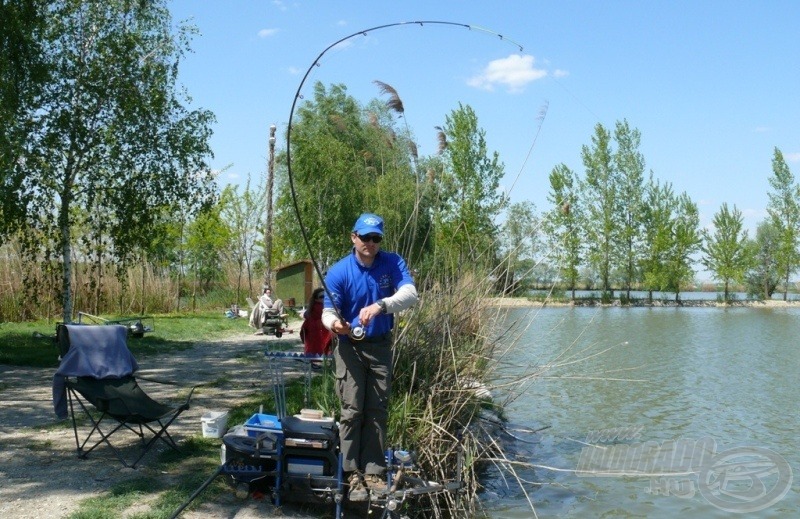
[436, 103, 506, 272]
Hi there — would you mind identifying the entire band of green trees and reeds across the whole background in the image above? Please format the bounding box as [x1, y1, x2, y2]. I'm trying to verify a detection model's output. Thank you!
[0, 0, 800, 320]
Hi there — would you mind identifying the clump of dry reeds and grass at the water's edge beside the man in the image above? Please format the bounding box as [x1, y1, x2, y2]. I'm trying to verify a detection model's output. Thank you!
[389, 275, 501, 517]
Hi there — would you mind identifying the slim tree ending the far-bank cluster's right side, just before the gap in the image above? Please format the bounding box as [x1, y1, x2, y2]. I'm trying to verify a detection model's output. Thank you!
[667, 192, 702, 301]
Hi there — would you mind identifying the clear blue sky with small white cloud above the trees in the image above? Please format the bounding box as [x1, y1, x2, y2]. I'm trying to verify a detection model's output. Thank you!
[170, 0, 800, 239]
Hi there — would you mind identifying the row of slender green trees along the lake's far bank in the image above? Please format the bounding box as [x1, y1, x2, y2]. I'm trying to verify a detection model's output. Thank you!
[541, 120, 800, 301]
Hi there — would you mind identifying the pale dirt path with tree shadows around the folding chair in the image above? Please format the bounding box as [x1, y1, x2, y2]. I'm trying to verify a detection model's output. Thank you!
[0, 323, 326, 519]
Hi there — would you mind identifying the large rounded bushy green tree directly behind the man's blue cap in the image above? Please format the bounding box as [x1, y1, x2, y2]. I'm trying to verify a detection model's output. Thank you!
[276, 83, 418, 270]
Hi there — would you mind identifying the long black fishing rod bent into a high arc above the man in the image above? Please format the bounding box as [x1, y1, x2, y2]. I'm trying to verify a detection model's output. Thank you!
[286, 20, 523, 322]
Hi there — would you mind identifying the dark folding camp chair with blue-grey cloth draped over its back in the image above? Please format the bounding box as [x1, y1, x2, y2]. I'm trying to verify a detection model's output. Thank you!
[53, 325, 194, 468]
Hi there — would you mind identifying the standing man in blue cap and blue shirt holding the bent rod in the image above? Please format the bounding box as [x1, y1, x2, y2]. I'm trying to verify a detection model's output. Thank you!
[322, 213, 418, 501]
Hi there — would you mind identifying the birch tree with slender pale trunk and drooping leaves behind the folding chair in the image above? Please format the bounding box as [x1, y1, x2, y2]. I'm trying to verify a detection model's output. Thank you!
[13, 0, 213, 321]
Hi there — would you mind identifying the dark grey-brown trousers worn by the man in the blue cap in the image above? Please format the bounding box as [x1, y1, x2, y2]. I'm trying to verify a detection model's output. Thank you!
[333, 337, 392, 474]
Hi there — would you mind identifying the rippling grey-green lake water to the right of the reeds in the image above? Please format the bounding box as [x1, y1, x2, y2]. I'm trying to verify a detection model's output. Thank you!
[487, 307, 800, 518]
